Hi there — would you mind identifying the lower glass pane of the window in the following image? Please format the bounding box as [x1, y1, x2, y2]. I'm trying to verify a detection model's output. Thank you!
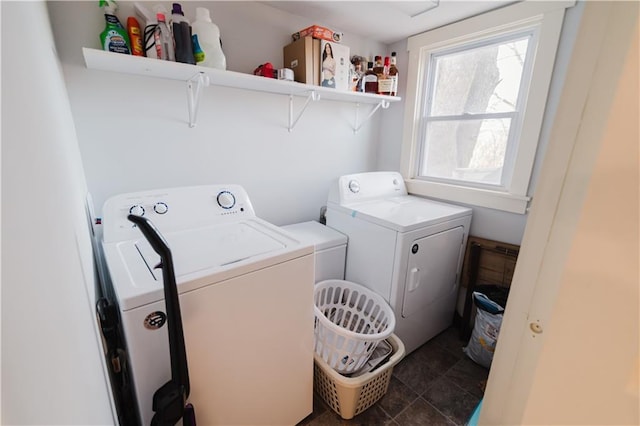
[420, 118, 511, 185]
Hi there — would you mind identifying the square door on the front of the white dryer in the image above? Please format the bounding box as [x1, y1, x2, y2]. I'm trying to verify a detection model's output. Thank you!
[402, 226, 464, 318]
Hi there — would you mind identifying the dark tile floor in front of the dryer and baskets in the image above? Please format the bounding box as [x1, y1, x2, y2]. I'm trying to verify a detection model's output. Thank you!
[299, 327, 489, 426]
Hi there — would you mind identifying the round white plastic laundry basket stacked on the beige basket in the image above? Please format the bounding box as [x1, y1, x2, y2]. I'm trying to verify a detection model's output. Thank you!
[314, 280, 396, 374]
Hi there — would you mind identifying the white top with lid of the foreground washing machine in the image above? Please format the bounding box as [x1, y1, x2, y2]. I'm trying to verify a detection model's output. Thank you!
[104, 218, 313, 311]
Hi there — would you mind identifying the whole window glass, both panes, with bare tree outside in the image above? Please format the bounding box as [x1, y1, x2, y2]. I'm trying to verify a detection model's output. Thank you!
[420, 35, 529, 189]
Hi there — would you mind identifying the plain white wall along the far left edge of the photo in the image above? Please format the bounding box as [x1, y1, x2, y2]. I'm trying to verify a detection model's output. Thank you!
[0, 1, 114, 425]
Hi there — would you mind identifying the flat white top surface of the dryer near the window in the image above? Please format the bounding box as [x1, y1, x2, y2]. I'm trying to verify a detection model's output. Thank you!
[327, 195, 471, 232]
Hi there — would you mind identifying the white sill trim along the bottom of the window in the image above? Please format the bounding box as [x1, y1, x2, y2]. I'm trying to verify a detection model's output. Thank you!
[405, 179, 531, 214]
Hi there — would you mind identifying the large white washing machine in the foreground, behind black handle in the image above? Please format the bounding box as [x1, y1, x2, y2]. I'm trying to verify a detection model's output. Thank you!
[103, 185, 314, 425]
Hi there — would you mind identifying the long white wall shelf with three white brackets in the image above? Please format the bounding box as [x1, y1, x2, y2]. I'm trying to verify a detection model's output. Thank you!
[82, 47, 401, 132]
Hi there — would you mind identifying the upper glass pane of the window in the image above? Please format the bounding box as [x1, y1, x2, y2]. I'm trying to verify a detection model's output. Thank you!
[430, 36, 529, 116]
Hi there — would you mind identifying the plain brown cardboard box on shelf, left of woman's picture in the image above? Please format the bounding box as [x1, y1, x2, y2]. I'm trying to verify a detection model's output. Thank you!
[283, 36, 321, 86]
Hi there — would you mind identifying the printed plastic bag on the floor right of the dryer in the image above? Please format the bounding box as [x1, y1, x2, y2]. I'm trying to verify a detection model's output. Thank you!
[463, 291, 504, 368]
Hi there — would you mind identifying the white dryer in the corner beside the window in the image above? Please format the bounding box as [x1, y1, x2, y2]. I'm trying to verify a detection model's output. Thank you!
[326, 172, 471, 353]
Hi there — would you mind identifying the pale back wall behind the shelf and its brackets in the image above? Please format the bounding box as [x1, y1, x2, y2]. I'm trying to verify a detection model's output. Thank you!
[49, 1, 395, 225]
